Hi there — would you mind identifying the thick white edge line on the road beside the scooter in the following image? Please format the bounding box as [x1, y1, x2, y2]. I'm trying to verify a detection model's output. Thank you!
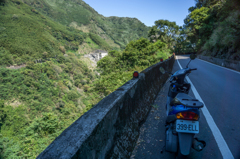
[176, 56, 234, 159]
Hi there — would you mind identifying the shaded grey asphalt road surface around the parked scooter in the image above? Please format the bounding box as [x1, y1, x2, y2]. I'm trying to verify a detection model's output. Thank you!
[131, 56, 240, 159]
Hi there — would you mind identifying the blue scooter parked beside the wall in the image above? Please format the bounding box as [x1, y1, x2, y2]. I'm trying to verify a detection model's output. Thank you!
[160, 54, 206, 159]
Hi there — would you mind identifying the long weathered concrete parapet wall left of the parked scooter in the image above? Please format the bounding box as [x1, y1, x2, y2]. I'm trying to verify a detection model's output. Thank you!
[37, 56, 175, 159]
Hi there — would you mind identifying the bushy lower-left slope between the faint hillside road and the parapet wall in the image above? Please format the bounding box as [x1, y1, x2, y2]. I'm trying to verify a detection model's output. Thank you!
[0, 53, 100, 158]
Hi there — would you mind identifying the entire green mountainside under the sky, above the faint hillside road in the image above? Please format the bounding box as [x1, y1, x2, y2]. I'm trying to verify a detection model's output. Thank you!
[0, 0, 149, 65]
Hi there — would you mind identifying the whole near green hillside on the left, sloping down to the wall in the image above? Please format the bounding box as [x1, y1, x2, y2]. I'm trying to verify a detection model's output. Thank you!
[0, 0, 100, 159]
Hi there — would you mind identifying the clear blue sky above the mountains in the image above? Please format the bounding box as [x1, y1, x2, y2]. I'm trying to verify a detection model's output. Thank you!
[83, 0, 195, 26]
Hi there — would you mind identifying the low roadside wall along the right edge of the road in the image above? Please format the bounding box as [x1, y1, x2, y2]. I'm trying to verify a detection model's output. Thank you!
[198, 55, 240, 71]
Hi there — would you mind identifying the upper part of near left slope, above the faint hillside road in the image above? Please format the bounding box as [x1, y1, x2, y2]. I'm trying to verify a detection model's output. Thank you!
[0, 0, 87, 65]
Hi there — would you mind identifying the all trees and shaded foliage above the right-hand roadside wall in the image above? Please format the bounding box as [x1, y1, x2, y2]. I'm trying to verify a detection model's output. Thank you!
[184, 0, 240, 60]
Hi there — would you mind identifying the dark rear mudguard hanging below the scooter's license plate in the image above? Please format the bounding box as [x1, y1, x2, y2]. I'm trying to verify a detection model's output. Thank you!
[178, 133, 195, 155]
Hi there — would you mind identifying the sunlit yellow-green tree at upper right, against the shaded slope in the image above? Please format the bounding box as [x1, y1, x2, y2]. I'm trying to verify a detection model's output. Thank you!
[184, 0, 231, 51]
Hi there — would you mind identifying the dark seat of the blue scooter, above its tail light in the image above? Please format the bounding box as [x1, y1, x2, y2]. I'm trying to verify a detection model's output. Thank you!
[170, 93, 203, 108]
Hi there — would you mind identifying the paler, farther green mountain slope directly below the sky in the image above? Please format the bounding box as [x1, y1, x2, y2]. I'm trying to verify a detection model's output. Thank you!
[19, 0, 148, 49]
